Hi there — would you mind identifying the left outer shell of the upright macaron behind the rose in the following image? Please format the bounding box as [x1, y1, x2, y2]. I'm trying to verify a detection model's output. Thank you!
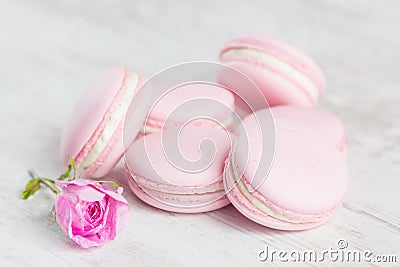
[61, 67, 127, 168]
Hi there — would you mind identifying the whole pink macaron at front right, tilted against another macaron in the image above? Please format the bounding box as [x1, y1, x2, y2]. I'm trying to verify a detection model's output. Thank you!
[224, 109, 348, 230]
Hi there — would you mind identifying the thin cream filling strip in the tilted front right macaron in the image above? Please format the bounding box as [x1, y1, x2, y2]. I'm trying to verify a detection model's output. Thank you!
[231, 153, 301, 223]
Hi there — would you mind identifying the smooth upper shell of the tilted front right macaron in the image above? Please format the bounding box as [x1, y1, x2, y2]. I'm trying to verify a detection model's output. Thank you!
[236, 118, 347, 217]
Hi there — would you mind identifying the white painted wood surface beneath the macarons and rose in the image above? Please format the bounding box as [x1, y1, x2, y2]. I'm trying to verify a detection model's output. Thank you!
[0, 0, 400, 266]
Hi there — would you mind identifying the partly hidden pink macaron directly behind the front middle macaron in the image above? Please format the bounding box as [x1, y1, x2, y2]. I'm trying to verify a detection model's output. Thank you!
[141, 83, 234, 134]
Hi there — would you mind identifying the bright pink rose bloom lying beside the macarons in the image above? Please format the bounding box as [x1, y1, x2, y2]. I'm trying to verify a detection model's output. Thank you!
[55, 179, 130, 248]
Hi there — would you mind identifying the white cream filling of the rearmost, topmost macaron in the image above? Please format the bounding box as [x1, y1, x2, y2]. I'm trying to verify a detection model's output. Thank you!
[222, 48, 319, 101]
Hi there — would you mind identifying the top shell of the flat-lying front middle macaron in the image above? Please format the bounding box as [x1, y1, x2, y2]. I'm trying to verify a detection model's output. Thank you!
[126, 126, 233, 187]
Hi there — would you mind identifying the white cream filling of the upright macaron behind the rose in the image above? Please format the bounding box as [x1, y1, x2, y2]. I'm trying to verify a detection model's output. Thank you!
[82, 74, 139, 169]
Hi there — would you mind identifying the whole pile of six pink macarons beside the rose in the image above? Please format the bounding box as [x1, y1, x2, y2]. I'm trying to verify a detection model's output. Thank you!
[61, 36, 347, 230]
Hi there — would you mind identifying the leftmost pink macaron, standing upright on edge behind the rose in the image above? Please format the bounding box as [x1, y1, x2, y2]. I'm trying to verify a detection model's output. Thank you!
[61, 67, 142, 177]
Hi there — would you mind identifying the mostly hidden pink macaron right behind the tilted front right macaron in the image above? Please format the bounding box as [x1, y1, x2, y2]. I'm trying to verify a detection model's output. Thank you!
[270, 106, 347, 155]
